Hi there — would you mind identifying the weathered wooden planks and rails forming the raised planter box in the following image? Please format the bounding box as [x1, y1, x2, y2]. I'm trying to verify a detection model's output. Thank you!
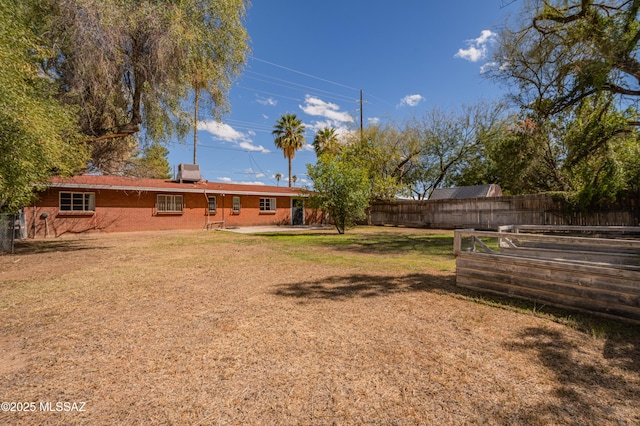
[455, 235, 640, 321]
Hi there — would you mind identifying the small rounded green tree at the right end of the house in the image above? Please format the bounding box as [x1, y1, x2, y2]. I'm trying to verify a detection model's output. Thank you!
[307, 156, 371, 234]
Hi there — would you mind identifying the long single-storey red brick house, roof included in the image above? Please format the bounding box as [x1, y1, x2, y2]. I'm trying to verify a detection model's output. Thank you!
[24, 175, 319, 238]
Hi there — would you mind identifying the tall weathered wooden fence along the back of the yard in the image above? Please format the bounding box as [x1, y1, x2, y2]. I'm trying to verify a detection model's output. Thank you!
[369, 194, 640, 230]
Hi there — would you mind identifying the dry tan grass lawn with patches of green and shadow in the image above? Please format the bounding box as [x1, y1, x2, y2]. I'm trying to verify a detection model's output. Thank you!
[0, 228, 640, 425]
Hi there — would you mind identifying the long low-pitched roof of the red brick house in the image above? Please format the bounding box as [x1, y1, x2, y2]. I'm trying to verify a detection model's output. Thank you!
[49, 175, 308, 197]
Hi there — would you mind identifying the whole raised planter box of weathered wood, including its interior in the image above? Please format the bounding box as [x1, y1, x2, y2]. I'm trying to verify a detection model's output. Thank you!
[454, 227, 640, 324]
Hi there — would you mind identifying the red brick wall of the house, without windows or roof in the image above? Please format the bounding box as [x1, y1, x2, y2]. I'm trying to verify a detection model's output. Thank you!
[25, 188, 315, 237]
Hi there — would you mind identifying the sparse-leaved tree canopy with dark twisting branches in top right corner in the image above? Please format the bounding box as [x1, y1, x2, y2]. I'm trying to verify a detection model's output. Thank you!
[491, 0, 640, 126]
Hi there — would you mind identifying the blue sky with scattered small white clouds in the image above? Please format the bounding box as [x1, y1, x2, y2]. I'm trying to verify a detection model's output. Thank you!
[169, 0, 518, 186]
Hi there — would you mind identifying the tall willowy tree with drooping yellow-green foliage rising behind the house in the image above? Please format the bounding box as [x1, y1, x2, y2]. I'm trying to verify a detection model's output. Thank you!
[34, 0, 248, 173]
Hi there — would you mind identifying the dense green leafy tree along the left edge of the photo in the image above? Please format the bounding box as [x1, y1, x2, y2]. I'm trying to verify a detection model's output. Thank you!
[0, 0, 87, 212]
